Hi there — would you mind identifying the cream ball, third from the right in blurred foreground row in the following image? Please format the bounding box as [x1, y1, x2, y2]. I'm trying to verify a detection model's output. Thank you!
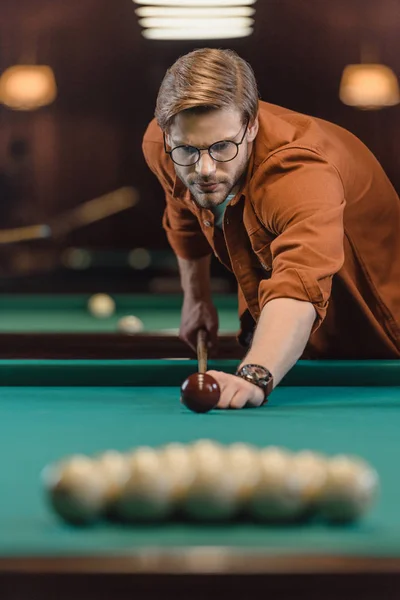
[248, 447, 304, 522]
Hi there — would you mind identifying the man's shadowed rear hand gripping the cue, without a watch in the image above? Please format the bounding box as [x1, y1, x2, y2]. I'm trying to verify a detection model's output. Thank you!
[179, 296, 218, 354]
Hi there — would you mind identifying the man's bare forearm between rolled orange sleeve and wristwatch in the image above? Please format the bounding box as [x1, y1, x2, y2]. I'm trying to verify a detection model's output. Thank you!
[242, 298, 316, 385]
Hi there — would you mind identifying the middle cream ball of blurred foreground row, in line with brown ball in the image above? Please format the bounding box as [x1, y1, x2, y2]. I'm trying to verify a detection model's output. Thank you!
[182, 440, 238, 521]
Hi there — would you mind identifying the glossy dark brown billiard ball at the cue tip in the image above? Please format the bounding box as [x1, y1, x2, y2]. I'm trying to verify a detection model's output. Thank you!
[181, 373, 221, 413]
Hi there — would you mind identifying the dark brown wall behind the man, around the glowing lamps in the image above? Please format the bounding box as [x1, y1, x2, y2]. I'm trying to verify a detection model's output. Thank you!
[0, 0, 400, 248]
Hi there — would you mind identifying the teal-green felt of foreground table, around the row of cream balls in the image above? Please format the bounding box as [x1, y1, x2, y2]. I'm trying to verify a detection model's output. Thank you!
[0, 370, 400, 556]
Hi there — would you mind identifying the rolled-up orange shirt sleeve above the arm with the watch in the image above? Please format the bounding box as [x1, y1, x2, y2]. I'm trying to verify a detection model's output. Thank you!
[252, 148, 345, 332]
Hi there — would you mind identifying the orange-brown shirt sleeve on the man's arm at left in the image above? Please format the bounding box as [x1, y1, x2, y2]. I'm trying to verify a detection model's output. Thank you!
[142, 134, 211, 260]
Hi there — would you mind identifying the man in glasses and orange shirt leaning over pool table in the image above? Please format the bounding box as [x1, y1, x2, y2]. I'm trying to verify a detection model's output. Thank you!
[143, 48, 400, 408]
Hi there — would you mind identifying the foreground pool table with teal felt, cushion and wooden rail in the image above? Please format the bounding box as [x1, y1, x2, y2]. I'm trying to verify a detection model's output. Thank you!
[0, 359, 400, 600]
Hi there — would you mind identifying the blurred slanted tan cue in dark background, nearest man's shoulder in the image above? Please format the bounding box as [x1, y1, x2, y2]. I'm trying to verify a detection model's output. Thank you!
[51, 186, 138, 237]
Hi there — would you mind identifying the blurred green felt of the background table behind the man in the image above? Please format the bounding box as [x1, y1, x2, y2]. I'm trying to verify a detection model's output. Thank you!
[0, 294, 239, 333]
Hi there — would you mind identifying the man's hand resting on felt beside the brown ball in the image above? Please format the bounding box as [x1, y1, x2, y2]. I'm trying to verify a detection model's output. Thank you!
[207, 371, 264, 408]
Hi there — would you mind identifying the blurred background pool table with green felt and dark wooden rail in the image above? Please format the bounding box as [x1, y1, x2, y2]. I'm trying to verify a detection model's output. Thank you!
[0, 294, 244, 359]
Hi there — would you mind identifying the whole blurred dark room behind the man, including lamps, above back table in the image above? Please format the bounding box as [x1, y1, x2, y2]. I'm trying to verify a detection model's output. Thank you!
[0, 0, 400, 294]
